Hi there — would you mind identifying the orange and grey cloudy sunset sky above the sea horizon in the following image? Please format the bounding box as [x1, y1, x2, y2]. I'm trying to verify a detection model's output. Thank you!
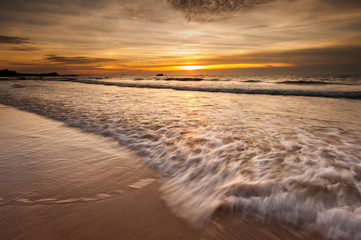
[0, 0, 361, 75]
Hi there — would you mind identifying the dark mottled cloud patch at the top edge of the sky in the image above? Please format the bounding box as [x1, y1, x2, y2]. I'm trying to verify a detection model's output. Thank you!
[167, 0, 273, 22]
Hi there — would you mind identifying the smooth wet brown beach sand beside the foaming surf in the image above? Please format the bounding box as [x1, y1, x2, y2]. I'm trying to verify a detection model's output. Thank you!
[0, 105, 320, 240]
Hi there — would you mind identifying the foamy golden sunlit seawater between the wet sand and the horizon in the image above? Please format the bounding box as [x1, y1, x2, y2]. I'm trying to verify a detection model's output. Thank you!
[0, 75, 361, 239]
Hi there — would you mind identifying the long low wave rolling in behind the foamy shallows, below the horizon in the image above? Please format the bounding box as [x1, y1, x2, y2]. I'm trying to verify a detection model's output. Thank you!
[59, 79, 361, 99]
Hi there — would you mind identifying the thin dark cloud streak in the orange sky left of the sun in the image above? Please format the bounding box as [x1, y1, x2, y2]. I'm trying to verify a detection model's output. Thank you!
[45, 54, 117, 65]
